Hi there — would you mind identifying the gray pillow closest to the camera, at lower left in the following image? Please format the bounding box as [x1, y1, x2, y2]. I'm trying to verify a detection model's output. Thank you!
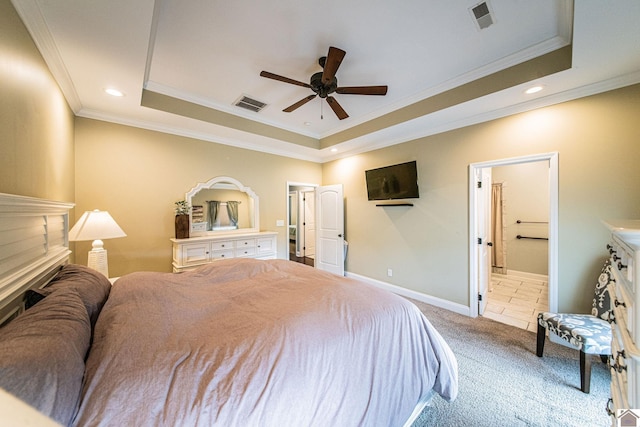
[0, 289, 91, 425]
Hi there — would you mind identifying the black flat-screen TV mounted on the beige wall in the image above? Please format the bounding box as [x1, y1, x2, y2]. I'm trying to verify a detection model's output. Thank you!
[364, 161, 420, 200]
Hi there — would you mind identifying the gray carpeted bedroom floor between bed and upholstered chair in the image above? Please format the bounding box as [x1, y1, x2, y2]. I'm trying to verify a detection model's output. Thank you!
[412, 300, 611, 427]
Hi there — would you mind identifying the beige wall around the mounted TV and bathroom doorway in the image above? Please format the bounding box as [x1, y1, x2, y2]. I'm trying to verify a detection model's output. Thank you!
[323, 85, 640, 311]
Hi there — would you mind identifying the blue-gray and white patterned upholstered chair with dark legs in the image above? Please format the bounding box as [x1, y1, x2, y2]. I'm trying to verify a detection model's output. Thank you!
[536, 260, 614, 393]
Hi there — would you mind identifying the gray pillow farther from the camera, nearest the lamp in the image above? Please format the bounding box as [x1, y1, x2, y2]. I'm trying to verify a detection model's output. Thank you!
[37, 264, 111, 329]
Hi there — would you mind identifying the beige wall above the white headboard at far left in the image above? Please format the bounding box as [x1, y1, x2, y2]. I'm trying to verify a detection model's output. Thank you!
[0, 0, 74, 202]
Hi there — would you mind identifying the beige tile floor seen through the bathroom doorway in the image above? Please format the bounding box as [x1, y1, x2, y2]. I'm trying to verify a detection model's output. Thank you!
[483, 273, 549, 332]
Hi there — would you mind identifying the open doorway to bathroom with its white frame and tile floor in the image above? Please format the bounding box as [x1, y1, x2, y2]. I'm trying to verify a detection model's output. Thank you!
[469, 153, 558, 330]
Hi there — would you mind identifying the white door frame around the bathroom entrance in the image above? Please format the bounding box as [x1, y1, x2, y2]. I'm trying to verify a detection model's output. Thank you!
[468, 152, 559, 317]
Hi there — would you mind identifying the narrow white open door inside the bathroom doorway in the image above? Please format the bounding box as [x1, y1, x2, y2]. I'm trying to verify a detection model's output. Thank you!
[476, 168, 492, 315]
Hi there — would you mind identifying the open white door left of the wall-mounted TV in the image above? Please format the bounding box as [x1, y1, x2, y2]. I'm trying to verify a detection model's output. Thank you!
[315, 184, 344, 276]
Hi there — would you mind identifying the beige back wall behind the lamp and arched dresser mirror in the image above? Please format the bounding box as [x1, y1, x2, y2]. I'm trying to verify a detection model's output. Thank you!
[75, 118, 322, 276]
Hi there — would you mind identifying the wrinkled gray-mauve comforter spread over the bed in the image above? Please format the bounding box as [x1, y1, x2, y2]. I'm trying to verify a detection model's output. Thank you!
[75, 259, 458, 427]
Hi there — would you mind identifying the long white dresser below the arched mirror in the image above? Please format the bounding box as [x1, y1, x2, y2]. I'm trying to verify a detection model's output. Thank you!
[171, 231, 278, 273]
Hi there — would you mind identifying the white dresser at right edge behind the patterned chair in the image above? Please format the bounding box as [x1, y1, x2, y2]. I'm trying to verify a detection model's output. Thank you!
[604, 220, 640, 425]
